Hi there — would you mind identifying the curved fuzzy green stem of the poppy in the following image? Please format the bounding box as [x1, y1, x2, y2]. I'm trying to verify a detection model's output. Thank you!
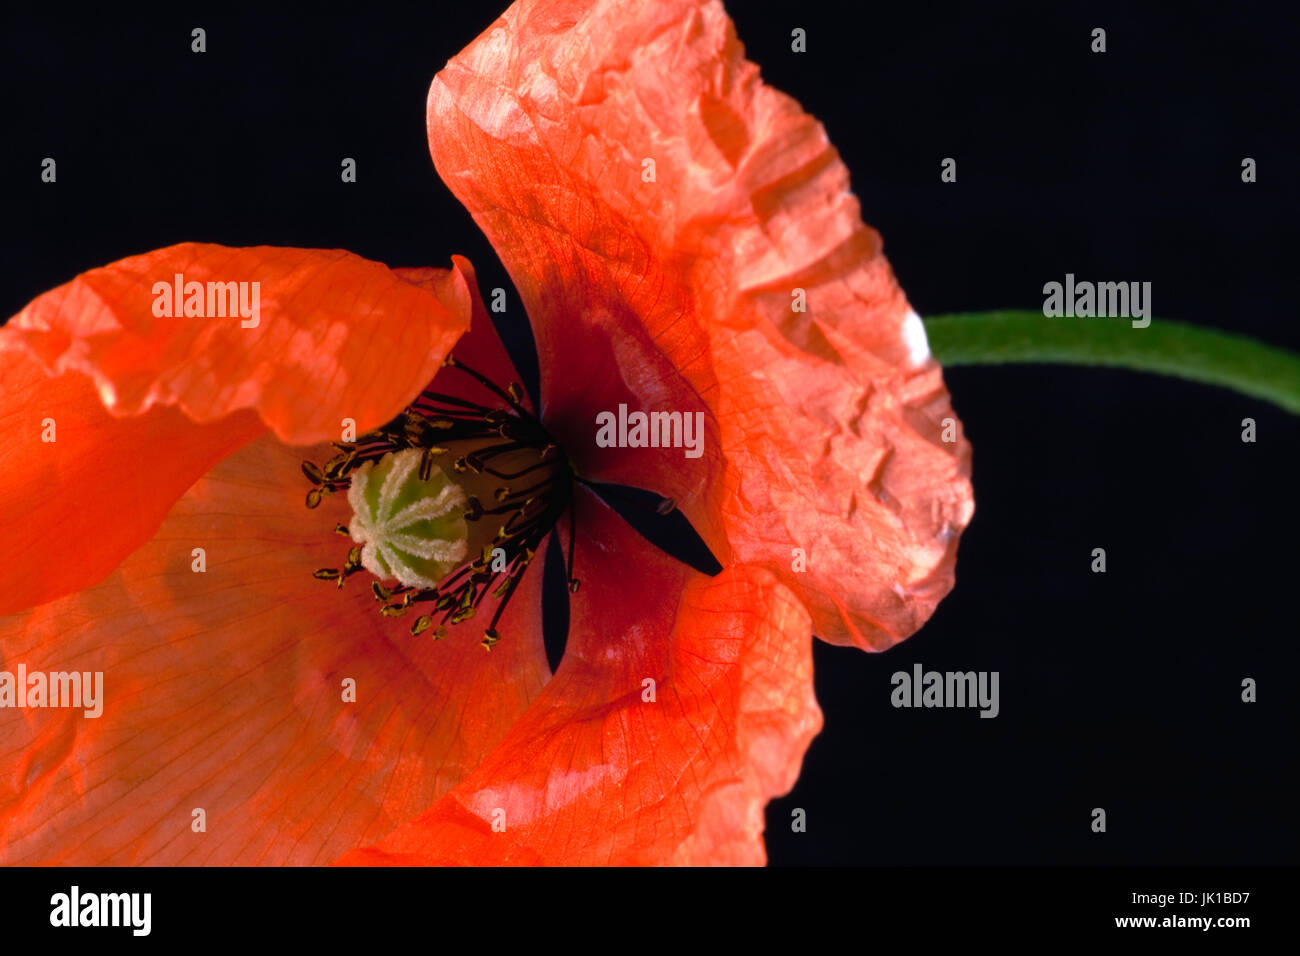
[926, 310, 1300, 415]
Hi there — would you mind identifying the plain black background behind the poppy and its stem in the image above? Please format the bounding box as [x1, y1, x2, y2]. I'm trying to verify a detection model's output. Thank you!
[0, 0, 1300, 865]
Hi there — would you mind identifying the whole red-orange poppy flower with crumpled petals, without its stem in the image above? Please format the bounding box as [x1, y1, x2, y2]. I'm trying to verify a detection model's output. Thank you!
[0, 0, 972, 864]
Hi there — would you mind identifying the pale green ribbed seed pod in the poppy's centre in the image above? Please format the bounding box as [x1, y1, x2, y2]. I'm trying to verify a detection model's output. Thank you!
[347, 449, 469, 588]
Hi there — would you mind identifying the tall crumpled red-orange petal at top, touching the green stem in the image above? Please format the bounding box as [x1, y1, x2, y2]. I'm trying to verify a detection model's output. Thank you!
[428, 0, 972, 648]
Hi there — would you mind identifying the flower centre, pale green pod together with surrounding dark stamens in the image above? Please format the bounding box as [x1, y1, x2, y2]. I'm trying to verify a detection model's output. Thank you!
[303, 355, 577, 649]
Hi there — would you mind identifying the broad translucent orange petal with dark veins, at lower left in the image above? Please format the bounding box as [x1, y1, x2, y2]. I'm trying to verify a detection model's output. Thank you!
[0, 436, 549, 865]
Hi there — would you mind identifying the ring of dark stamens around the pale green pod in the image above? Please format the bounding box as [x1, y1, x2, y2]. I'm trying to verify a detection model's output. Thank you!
[303, 355, 579, 649]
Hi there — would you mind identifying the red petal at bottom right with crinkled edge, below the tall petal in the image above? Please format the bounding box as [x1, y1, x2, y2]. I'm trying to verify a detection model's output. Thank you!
[339, 492, 822, 865]
